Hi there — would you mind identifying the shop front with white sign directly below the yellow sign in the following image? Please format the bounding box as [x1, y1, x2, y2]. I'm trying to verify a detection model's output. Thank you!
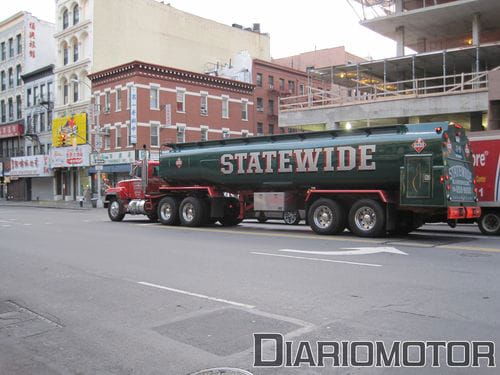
[50, 145, 91, 201]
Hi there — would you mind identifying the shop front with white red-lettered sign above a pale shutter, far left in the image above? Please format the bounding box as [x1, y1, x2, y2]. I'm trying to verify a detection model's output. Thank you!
[10, 155, 54, 201]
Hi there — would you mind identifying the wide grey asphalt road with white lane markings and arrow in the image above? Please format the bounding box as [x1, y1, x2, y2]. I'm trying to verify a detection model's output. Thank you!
[0, 207, 500, 375]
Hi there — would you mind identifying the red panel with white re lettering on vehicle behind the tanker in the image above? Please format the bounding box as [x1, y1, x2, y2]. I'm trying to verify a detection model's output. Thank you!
[472, 137, 500, 202]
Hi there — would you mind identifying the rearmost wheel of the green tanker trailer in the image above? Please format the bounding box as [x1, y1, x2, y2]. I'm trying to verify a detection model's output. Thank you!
[349, 199, 386, 237]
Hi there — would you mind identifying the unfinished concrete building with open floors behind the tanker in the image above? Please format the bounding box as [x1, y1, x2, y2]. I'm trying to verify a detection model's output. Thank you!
[280, 0, 500, 130]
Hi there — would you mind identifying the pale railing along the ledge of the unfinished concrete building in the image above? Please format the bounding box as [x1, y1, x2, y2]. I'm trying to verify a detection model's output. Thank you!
[279, 67, 494, 112]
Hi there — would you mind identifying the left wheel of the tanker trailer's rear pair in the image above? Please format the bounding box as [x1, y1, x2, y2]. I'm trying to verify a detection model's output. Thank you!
[307, 198, 346, 234]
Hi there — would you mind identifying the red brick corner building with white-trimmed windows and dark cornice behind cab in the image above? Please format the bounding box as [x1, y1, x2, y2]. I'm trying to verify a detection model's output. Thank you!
[89, 61, 255, 189]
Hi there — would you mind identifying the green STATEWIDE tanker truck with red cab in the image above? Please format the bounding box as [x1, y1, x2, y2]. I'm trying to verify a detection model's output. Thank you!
[105, 122, 481, 237]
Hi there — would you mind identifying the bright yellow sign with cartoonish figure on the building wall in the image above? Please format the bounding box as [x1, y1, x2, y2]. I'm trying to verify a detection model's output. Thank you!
[52, 113, 87, 147]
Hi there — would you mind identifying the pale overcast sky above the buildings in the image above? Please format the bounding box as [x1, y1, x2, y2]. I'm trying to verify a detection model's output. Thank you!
[0, 0, 396, 59]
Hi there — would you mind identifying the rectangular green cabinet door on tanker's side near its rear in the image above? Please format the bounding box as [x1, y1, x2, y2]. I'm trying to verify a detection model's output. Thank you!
[400, 155, 433, 205]
